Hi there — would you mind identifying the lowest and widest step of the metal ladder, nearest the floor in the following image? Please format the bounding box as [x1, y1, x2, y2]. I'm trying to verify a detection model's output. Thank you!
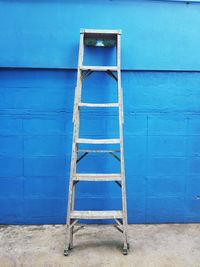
[70, 210, 123, 219]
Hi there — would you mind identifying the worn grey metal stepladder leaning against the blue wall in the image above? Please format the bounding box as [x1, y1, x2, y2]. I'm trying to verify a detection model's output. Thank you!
[64, 29, 129, 256]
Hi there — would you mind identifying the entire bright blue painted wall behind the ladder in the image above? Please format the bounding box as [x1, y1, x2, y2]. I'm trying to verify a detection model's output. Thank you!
[0, 0, 200, 224]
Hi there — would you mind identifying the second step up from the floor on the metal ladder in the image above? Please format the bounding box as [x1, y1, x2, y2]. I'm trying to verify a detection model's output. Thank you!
[73, 173, 122, 182]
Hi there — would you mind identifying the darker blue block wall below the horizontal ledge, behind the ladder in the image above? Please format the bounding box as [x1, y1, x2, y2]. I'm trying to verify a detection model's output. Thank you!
[0, 69, 200, 224]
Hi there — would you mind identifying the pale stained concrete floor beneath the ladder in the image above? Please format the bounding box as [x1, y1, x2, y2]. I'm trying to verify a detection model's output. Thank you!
[0, 224, 200, 267]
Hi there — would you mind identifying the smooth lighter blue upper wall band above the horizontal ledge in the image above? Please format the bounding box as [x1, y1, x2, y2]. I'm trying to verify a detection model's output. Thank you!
[0, 0, 200, 70]
